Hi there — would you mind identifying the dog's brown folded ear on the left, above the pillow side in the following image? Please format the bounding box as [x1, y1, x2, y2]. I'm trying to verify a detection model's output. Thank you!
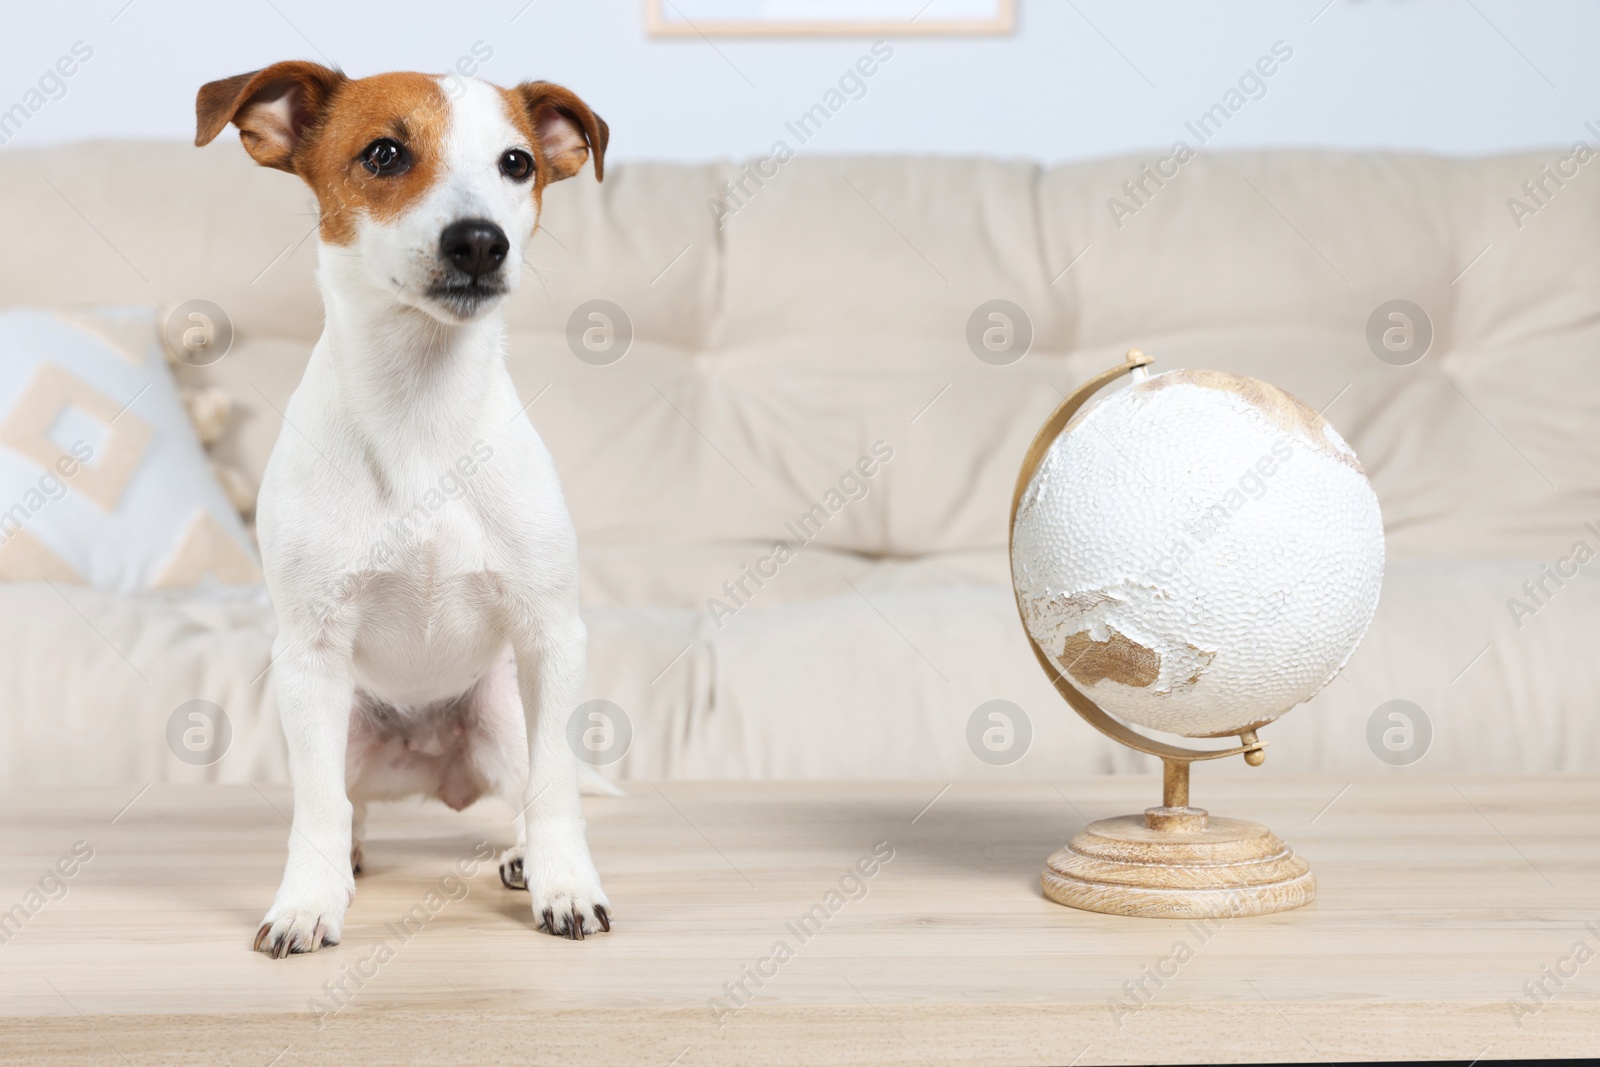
[195, 59, 346, 173]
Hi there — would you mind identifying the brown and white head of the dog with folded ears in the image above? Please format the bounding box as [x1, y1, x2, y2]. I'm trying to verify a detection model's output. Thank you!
[195, 61, 608, 323]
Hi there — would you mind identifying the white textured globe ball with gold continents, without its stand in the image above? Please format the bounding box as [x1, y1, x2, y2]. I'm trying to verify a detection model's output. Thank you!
[1011, 370, 1384, 737]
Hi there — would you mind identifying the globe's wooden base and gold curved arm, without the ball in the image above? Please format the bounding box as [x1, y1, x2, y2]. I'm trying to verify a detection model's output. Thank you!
[1011, 349, 1317, 918]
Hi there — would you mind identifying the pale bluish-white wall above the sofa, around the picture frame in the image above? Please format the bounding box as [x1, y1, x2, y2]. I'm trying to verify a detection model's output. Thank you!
[0, 0, 1600, 160]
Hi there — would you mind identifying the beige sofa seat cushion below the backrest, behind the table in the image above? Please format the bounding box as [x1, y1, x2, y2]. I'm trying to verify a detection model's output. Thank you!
[0, 559, 1600, 790]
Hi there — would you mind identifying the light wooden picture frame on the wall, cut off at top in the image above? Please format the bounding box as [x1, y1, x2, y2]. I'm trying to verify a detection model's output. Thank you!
[645, 0, 1016, 37]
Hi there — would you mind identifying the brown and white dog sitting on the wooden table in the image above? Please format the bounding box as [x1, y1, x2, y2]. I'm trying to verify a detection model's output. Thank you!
[195, 61, 611, 958]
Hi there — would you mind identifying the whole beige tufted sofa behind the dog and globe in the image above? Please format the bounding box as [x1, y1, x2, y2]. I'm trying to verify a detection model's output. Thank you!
[0, 139, 1600, 789]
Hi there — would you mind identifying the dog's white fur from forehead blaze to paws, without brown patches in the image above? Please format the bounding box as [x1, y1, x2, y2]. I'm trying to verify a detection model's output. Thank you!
[258, 82, 608, 955]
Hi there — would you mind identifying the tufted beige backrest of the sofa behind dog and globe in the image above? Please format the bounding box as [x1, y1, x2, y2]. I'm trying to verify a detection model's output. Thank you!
[0, 138, 1600, 558]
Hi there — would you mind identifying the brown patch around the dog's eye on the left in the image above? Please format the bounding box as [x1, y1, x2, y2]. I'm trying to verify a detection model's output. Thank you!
[294, 74, 450, 245]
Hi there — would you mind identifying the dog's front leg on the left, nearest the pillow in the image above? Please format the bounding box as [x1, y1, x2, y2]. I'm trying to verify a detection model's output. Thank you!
[254, 635, 355, 958]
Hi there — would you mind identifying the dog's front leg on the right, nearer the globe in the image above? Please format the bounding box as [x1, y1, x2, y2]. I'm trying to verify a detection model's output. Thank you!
[517, 606, 611, 941]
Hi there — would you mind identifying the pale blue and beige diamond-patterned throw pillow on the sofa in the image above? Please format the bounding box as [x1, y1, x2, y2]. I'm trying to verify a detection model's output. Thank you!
[0, 309, 261, 592]
